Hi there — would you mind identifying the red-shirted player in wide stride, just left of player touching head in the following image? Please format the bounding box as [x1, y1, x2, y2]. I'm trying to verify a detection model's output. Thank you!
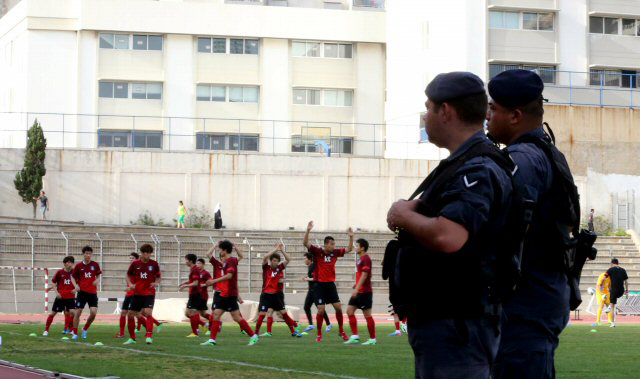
[201, 240, 258, 346]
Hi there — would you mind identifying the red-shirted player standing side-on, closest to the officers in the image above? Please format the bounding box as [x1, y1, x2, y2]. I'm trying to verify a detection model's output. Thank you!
[345, 238, 376, 345]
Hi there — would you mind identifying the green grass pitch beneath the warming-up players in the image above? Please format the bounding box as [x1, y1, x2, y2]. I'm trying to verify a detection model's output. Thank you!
[0, 323, 640, 379]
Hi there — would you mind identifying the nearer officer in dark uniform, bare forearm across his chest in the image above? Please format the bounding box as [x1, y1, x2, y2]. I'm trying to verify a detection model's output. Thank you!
[385, 72, 512, 379]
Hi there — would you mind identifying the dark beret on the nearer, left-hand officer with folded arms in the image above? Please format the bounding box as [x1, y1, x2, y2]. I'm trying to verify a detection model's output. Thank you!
[424, 71, 485, 103]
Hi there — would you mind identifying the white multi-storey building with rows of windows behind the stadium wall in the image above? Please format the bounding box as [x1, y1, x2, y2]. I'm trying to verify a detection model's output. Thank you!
[0, 0, 640, 159]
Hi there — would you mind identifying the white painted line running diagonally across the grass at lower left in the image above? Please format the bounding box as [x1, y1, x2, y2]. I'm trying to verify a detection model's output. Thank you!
[6, 332, 366, 379]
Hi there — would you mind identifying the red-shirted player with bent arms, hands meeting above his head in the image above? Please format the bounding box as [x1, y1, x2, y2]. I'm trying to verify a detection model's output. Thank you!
[256, 243, 301, 337]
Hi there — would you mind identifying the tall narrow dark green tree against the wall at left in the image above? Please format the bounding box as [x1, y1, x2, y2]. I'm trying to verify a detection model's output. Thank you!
[13, 119, 47, 218]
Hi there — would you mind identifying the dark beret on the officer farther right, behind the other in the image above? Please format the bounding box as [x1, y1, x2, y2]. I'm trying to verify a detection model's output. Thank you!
[489, 70, 544, 108]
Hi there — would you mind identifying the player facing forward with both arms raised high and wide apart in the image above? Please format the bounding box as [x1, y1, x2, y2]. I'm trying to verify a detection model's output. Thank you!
[303, 221, 353, 342]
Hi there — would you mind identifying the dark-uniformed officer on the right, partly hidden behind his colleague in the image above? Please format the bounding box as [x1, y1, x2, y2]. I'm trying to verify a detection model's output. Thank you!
[487, 70, 570, 379]
